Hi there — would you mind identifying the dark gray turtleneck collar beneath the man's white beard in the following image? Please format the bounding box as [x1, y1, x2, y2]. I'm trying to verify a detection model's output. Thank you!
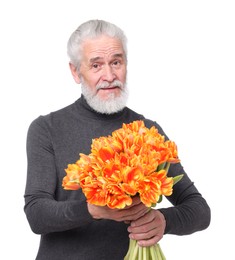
[75, 95, 126, 120]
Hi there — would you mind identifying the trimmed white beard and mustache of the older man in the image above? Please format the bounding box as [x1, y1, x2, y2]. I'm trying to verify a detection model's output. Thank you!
[81, 80, 128, 114]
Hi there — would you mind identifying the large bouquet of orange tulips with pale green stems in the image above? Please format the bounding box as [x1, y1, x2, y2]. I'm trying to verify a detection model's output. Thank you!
[62, 120, 183, 260]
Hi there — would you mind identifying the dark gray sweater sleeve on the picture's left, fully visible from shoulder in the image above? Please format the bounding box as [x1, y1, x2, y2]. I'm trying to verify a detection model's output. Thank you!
[24, 118, 92, 234]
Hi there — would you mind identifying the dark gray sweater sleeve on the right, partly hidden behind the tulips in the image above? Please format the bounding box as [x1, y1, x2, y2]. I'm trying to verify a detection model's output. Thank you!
[159, 163, 211, 235]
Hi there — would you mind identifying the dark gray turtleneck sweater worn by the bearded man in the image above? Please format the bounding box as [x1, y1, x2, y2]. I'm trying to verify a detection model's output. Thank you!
[24, 96, 210, 260]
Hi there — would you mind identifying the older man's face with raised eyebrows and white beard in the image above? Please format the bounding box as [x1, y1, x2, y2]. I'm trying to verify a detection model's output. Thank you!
[70, 36, 127, 114]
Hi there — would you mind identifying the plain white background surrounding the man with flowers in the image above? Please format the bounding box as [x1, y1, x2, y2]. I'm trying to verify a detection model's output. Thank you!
[0, 0, 235, 260]
